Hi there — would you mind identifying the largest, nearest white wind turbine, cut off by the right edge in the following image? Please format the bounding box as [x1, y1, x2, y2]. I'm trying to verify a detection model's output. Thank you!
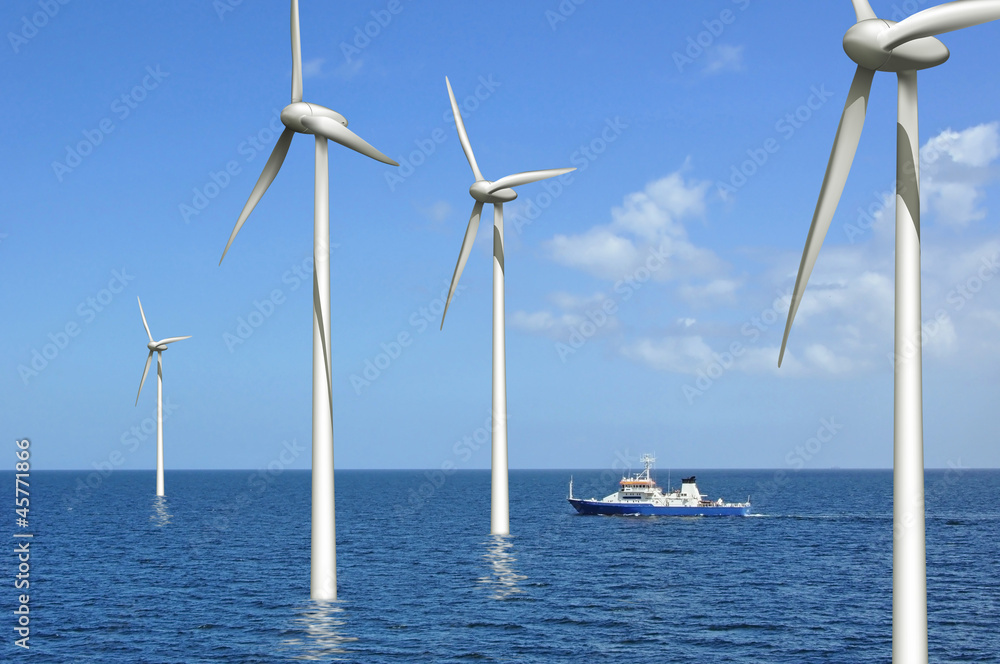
[778, 0, 1000, 663]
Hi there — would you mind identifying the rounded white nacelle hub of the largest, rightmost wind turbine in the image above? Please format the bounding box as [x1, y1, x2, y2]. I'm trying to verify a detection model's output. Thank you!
[844, 18, 951, 72]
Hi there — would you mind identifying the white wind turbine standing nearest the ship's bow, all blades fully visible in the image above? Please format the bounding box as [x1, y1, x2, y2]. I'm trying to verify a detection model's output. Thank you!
[441, 76, 576, 535]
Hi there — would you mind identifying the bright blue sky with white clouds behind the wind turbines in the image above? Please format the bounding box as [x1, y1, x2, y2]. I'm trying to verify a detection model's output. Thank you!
[0, 0, 1000, 473]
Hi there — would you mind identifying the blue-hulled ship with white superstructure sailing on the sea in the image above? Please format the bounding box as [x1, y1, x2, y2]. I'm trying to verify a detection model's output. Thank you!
[568, 454, 750, 516]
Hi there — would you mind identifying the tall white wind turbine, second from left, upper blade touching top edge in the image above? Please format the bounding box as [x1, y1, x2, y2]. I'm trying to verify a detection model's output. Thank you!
[219, 0, 399, 600]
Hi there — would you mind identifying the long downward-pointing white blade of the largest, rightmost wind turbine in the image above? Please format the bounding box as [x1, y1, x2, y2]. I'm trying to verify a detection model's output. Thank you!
[778, 67, 875, 367]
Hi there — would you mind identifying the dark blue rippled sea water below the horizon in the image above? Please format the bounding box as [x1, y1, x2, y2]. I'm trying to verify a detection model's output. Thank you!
[7, 470, 1000, 664]
